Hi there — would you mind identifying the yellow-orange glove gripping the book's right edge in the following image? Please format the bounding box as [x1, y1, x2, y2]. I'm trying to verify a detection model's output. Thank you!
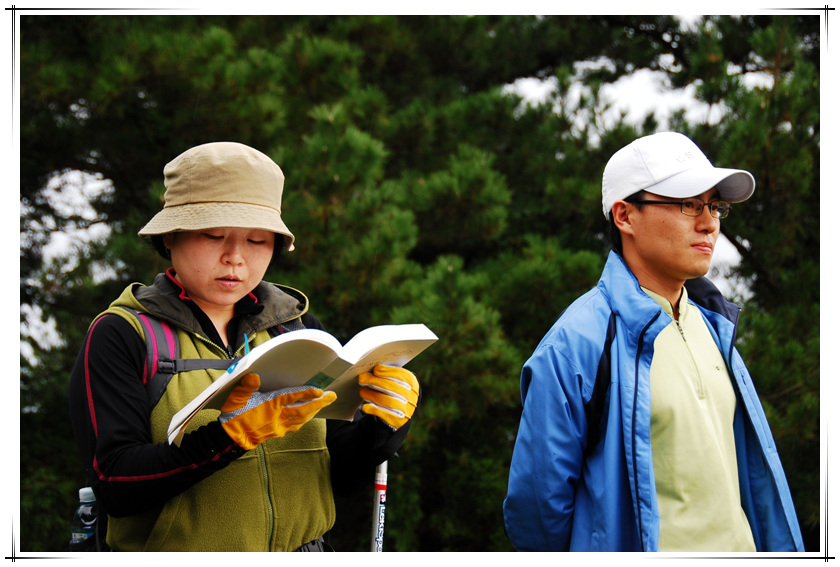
[359, 364, 420, 429]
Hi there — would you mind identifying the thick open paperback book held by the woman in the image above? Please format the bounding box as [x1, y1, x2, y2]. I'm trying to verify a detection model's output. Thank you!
[168, 324, 438, 445]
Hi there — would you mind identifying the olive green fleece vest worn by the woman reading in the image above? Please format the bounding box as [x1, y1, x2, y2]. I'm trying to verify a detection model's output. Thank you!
[100, 286, 335, 551]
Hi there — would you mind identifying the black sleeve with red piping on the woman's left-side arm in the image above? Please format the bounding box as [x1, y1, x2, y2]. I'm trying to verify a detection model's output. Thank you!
[70, 315, 243, 516]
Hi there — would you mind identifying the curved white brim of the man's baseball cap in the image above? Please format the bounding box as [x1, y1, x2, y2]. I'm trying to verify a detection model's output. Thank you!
[645, 167, 755, 203]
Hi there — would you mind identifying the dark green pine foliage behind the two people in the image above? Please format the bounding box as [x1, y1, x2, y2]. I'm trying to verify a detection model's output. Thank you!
[17, 14, 821, 552]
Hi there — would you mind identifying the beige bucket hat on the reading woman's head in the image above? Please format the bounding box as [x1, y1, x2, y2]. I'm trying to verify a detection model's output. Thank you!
[138, 142, 295, 250]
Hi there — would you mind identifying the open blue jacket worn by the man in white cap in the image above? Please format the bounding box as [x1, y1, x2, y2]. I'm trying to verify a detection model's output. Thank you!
[504, 252, 804, 551]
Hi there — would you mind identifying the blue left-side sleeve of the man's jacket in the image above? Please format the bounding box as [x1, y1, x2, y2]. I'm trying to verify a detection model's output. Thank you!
[504, 344, 587, 551]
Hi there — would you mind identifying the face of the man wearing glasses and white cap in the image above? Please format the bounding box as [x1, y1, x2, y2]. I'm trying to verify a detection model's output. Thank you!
[625, 188, 720, 287]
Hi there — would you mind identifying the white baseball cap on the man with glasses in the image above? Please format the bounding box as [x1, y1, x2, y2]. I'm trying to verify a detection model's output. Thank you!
[601, 132, 755, 219]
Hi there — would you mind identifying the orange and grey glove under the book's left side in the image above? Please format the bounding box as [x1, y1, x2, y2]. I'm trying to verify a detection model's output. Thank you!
[219, 373, 336, 450]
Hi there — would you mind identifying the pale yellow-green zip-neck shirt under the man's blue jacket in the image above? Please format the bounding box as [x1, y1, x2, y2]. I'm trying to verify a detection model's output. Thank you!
[642, 288, 755, 552]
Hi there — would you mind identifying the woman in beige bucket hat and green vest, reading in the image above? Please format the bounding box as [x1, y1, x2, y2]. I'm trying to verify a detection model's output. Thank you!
[70, 142, 419, 551]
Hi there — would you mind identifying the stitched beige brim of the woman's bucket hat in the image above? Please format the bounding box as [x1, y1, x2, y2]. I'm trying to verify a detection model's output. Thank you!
[138, 203, 295, 251]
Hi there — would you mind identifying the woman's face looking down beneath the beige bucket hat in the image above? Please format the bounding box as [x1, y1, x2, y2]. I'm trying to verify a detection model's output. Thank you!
[163, 228, 275, 316]
